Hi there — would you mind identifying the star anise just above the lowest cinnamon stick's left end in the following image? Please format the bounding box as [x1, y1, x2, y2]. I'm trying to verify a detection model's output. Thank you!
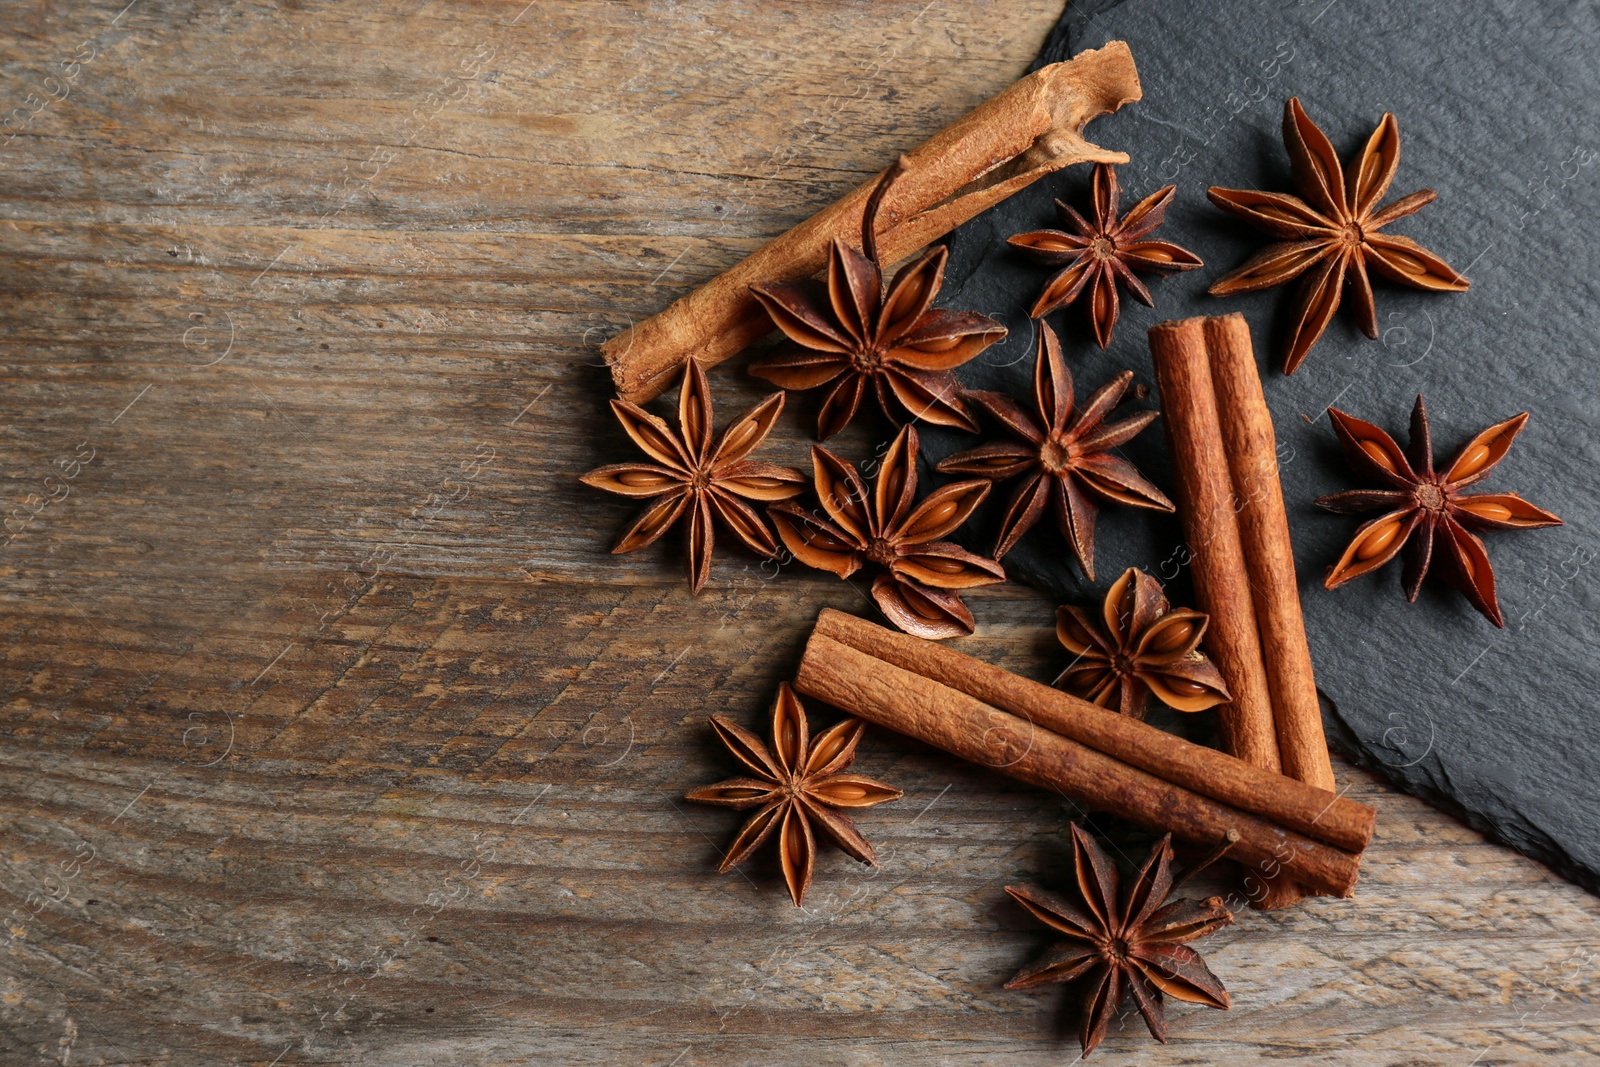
[766, 426, 1005, 640]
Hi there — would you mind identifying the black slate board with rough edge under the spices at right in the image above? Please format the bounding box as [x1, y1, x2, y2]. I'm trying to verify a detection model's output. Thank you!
[925, 0, 1600, 891]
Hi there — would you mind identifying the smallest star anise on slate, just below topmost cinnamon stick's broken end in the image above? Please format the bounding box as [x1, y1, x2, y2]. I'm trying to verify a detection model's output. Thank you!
[1006, 163, 1203, 349]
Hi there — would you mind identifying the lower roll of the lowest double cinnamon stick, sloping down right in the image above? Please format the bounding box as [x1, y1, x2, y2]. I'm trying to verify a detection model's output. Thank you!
[795, 632, 1360, 896]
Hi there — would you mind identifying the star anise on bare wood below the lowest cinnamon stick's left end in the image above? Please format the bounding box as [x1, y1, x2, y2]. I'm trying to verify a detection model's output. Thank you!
[686, 681, 904, 907]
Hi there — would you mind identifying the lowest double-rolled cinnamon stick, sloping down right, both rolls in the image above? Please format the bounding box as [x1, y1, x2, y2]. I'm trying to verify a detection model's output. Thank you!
[795, 609, 1374, 896]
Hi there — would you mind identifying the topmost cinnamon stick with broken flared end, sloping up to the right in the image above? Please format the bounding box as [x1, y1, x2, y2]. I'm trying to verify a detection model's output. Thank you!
[600, 42, 1142, 403]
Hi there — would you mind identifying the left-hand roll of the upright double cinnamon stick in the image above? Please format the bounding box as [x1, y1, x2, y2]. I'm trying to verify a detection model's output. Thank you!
[1150, 318, 1282, 771]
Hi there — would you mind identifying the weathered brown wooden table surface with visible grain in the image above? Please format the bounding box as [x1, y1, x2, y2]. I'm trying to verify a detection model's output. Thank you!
[0, 0, 1600, 1067]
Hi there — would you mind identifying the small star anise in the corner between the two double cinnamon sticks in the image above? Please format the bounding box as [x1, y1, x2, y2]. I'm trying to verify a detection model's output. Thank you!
[1054, 568, 1229, 718]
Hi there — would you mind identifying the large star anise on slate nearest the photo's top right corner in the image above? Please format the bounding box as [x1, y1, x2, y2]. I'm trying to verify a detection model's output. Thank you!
[1206, 98, 1469, 374]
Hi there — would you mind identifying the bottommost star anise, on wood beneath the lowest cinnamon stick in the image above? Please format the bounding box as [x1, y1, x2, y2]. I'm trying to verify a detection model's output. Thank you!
[1005, 824, 1234, 1056]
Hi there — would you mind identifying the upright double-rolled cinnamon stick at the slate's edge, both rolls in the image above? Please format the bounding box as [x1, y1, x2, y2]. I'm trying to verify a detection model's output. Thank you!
[1150, 314, 1334, 905]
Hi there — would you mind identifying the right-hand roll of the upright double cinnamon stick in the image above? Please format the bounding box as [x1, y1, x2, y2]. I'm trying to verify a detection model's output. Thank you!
[1205, 312, 1334, 790]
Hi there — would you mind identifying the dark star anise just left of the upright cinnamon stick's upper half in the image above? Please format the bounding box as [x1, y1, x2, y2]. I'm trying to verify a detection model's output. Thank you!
[939, 322, 1173, 581]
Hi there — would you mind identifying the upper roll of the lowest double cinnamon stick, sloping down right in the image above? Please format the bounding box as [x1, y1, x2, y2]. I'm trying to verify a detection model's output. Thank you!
[814, 608, 1376, 853]
